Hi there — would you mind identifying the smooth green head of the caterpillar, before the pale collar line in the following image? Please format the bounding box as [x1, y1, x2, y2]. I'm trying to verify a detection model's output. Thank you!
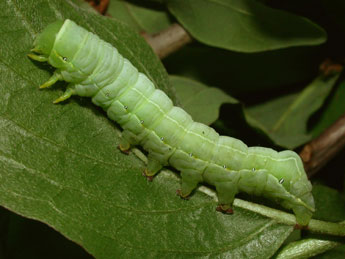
[32, 21, 64, 58]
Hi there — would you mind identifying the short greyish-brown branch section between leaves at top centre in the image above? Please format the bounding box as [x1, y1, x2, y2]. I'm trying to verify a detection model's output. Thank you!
[142, 23, 193, 59]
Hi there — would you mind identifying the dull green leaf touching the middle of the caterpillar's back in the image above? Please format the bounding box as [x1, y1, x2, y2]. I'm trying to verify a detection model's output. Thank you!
[170, 76, 239, 125]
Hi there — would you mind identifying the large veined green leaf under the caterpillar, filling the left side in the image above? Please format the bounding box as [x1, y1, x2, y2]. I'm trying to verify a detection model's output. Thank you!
[0, 0, 292, 258]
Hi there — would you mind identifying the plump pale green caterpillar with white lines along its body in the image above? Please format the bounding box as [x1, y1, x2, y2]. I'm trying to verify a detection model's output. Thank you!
[28, 19, 314, 226]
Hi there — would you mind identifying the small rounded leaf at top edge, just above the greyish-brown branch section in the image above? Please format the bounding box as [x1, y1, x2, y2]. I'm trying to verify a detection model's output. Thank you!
[108, 0, 171, 34]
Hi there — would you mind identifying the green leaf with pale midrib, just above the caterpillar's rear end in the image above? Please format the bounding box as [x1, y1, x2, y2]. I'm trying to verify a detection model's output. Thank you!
[245, 73, 340, 149]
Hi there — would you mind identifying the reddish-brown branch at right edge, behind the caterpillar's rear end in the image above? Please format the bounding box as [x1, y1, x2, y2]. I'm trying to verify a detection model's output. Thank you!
[300, 114, 345, 177]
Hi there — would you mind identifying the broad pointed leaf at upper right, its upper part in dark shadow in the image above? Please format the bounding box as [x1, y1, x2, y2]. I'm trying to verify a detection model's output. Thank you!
[166, 0, 326, 52]
